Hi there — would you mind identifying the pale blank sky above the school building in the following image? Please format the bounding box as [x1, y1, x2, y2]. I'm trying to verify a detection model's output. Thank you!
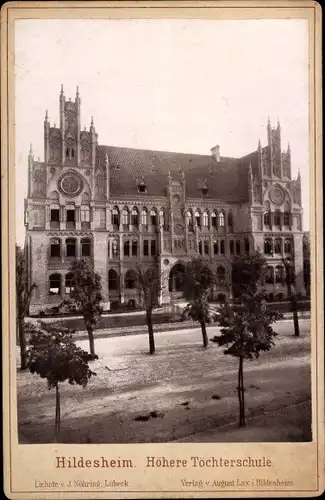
[15, 19, 309, 243]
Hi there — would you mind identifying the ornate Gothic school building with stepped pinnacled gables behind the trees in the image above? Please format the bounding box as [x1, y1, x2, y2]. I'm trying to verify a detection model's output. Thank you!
[25, 87, 305, 314]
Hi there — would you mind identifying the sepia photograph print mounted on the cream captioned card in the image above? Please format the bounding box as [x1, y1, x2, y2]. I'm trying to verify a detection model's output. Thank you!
[14, 15, 312, 444]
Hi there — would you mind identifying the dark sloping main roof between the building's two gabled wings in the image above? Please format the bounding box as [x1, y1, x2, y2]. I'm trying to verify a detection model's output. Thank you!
[96, 146, 249, 202]
